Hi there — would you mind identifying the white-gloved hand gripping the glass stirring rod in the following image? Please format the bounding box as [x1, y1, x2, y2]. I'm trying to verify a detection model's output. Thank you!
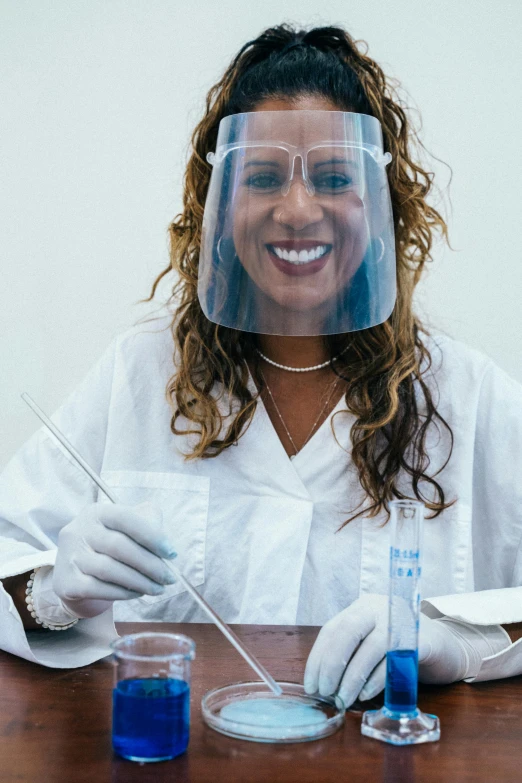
[47, 503, 176, 617]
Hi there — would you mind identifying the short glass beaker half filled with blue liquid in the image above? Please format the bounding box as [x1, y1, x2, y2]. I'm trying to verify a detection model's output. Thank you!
[111, 633, 196, 761]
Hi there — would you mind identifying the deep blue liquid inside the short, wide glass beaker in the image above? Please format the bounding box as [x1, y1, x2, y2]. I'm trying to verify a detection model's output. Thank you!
[112, 677, 190, 761]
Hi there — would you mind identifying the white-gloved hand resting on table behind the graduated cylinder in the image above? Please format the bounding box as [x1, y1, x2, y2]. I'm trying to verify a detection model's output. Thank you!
[304, 593, 504, 707]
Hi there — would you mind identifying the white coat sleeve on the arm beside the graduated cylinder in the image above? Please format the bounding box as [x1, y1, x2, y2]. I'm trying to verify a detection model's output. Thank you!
[421, 363, 522, 682]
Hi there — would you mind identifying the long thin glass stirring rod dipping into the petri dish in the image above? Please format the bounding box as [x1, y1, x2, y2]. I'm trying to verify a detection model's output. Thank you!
[21, 392, 283, 696]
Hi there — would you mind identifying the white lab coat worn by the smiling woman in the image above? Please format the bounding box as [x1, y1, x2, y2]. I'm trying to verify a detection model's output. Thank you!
[0, 319, 522, 679]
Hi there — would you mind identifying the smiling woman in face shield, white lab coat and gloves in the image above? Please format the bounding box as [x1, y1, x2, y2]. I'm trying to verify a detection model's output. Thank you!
[0, 26, 522, 704]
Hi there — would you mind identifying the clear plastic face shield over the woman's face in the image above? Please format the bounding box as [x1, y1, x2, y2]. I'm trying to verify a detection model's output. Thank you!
[198, 111, 396, 336]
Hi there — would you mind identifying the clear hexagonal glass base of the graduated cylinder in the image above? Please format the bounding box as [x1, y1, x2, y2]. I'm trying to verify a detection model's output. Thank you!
[361, 707, 440, 745]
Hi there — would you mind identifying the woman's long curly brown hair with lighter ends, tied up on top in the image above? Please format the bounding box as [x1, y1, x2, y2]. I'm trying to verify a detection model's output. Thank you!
[144, 25, 454, 524]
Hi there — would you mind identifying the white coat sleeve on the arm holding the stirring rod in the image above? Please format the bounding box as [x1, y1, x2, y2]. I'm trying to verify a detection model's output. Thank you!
[0, 340, 117, 668]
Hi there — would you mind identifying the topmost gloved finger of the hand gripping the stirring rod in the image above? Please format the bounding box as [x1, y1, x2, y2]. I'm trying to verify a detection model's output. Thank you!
[98, 503, 176, 557]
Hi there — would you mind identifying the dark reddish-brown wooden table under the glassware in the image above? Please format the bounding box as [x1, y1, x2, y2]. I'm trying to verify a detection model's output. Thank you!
[0, 623, 522, 783]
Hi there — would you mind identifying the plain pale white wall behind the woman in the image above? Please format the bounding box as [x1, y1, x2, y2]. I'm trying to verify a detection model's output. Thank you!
[0, 0, 522, 467]
